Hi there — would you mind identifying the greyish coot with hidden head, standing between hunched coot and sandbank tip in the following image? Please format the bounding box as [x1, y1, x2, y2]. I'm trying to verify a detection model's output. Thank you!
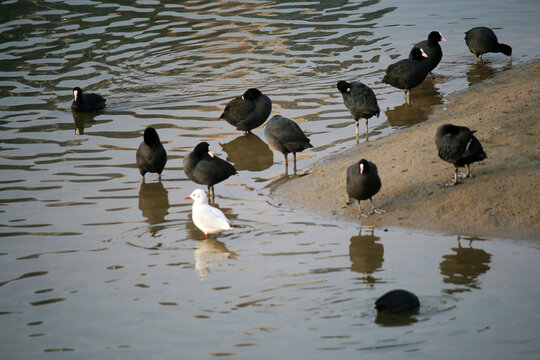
[264, 115, 313, 173]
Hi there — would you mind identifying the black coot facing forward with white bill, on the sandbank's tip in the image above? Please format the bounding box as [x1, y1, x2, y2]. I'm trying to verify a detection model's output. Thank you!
[347, 159, 384, 217]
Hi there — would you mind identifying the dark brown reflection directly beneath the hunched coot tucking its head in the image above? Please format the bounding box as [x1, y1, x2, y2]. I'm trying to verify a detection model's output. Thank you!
[220, 133, 274, 171]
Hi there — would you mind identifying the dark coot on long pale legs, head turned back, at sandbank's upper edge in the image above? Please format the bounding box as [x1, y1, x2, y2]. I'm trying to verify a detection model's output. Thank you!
[337, 80, 380, 143]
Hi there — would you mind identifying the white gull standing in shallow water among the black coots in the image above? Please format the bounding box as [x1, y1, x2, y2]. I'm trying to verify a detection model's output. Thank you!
[186, 189, 231, 239]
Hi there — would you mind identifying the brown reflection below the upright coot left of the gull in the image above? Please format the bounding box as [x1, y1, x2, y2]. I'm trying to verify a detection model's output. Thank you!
[139, 182, 169, 236]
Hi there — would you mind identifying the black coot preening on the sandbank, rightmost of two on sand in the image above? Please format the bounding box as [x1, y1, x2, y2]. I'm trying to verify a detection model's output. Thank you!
[435, 124, 487, 186]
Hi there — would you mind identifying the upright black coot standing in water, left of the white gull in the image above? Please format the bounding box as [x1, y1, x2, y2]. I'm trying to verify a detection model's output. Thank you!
[137, 126, 167, 181]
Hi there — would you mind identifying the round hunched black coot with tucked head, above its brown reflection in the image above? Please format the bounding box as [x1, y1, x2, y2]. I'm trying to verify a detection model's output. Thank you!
[219, 89, 272, 133]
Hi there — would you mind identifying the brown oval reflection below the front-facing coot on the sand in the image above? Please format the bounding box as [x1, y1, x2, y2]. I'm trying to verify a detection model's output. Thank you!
[349, 228, 384, 284]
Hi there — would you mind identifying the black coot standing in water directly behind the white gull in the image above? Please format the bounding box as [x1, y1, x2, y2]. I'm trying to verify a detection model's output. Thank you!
[184, 142, 236, 201]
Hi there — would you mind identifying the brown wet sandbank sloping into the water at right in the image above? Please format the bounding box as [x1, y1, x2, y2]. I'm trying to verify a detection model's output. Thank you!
[273, 60, 540, 240]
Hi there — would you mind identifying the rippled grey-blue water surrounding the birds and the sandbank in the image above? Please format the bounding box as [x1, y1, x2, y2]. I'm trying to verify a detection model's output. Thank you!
[0, 1, 540, 359]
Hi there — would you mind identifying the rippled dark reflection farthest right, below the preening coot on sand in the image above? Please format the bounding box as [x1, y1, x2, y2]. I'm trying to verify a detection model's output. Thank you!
[439, 236, 491, 294]
